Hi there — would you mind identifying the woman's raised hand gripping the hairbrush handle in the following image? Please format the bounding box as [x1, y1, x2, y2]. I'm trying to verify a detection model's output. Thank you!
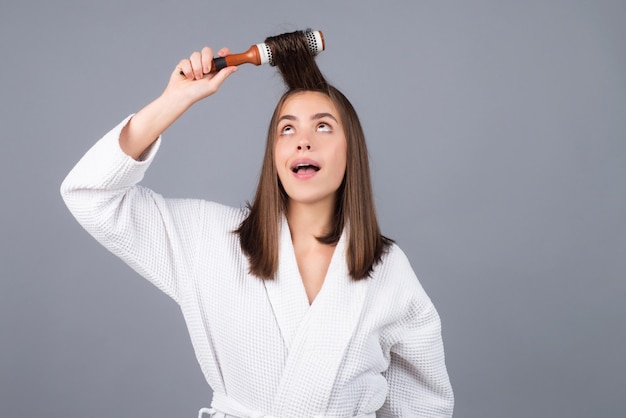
[163, 46, 237, 106]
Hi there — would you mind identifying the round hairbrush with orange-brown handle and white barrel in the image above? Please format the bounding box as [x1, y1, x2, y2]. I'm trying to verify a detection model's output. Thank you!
[181, 30, 324, 74]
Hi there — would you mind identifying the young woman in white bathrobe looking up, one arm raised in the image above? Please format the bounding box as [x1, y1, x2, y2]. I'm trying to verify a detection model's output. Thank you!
[61, 47, 453, 418]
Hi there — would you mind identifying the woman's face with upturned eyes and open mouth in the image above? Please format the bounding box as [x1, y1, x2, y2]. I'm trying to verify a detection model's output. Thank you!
[274, 91, 348, 209]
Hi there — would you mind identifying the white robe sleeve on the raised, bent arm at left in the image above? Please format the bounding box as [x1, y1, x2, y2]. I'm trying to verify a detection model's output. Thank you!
[61, 115, 194, 303]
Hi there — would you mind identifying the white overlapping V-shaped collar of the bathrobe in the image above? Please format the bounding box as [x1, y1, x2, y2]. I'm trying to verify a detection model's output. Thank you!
[265, 217, 370, 416]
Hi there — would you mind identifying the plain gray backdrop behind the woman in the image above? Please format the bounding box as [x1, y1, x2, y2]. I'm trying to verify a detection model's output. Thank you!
[0, 0, 626, 418]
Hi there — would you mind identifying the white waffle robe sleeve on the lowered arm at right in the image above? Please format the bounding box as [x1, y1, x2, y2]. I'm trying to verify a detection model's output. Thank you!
[377, 250, 454, 418]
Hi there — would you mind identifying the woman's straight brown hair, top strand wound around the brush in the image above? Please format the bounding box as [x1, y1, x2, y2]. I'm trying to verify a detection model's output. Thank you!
[235, 32, 393, 280]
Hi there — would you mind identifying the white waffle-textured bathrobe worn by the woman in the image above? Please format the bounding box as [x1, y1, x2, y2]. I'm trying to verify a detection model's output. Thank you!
[61, 119, 454, 418]
